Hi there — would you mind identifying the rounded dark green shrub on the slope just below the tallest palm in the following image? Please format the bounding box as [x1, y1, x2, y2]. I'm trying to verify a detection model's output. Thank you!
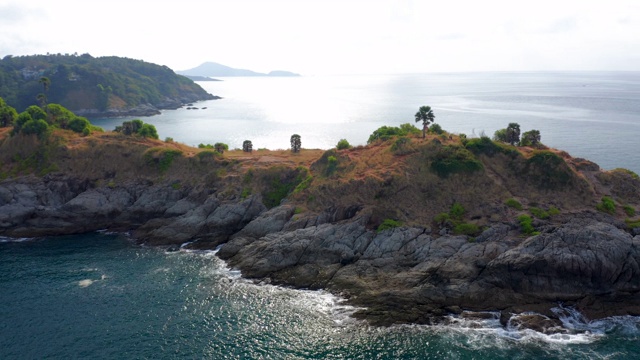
[431, 145, 484, 178]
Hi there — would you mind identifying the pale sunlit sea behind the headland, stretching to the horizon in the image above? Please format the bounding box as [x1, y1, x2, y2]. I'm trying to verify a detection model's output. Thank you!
[92, 72, 640, 173]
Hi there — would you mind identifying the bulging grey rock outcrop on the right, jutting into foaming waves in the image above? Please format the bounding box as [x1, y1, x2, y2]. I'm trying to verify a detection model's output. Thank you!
[219, 220, 640, 324]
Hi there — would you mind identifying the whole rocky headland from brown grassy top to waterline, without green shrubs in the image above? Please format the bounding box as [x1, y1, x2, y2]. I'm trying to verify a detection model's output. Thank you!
[0, 134, 640, 324]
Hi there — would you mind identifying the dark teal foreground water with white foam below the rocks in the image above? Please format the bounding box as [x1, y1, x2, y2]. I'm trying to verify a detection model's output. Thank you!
[0, 233, 640, 359]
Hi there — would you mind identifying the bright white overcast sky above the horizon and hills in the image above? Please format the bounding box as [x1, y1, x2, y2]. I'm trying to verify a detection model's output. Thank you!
[0, 0, 640, 75]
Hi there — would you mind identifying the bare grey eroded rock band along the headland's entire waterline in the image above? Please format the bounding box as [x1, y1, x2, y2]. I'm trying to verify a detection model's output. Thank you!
[0, 176, 640, 328]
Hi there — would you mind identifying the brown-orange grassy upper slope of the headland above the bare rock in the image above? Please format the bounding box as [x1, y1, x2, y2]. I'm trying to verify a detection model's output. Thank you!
[0, 113, 640, 238]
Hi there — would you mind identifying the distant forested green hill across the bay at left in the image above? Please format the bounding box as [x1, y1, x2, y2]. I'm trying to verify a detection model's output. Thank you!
[0, 54, 215, 116]
